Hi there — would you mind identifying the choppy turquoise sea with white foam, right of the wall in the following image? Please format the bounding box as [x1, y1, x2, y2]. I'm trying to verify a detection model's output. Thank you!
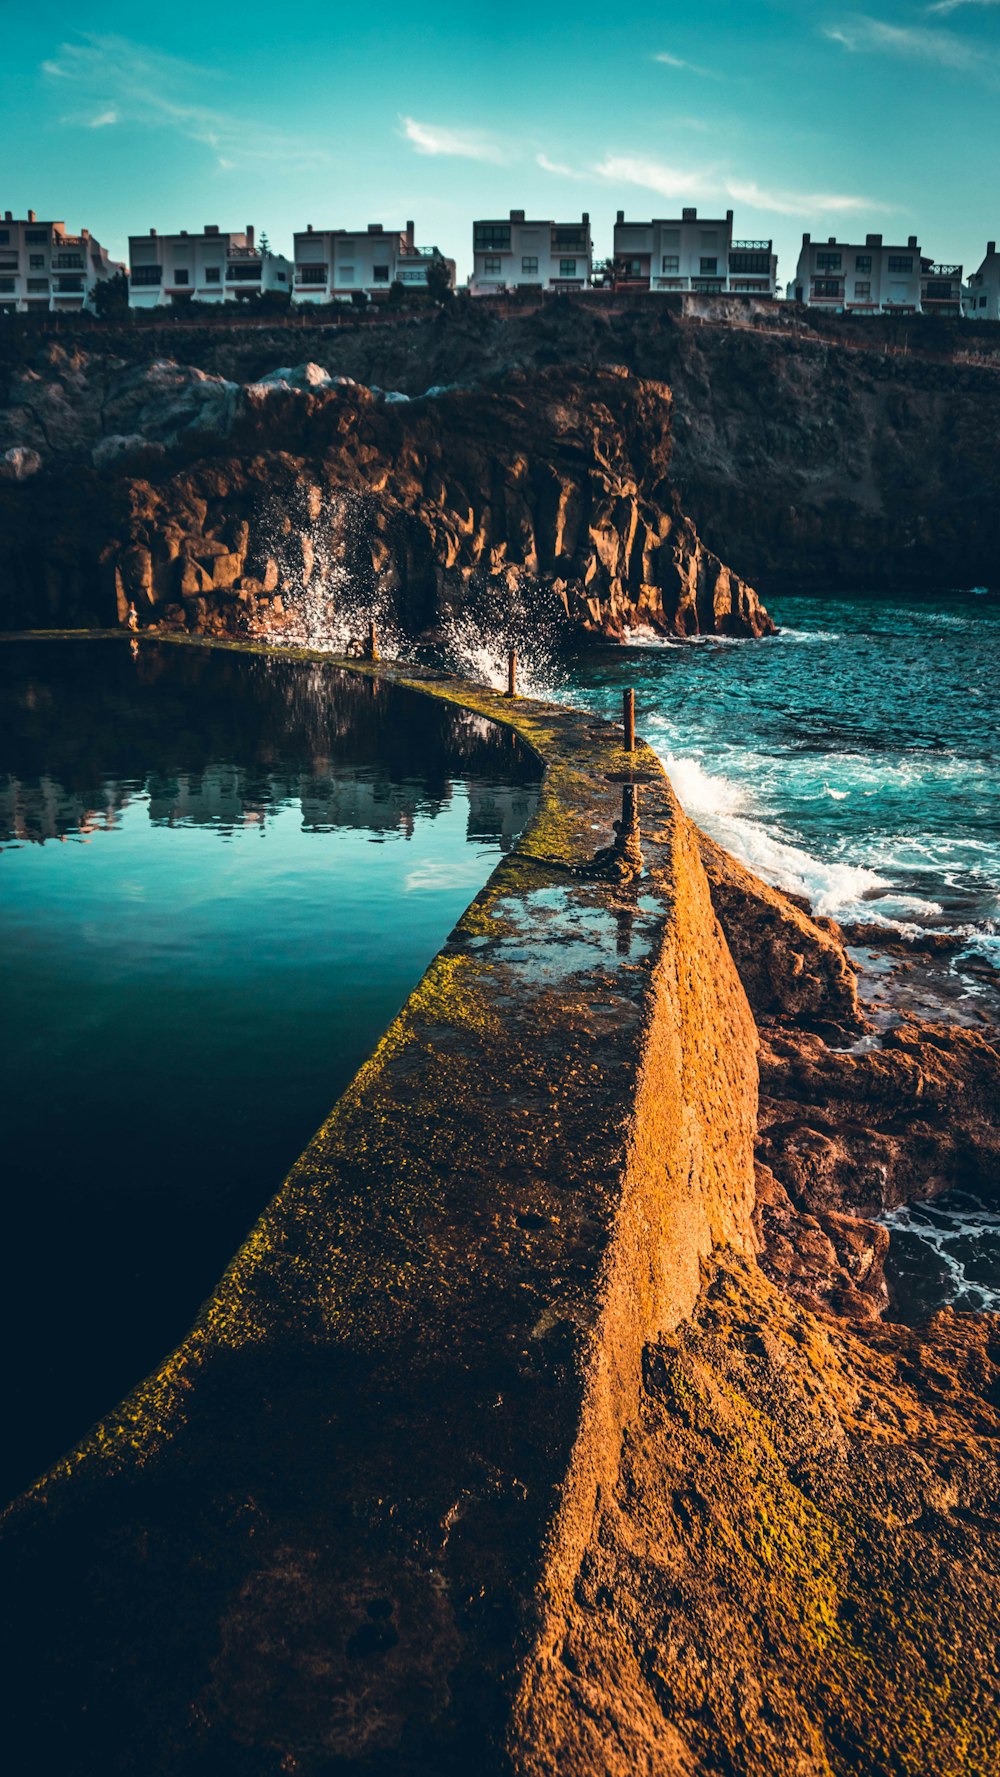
[554, 594, 1000, 1319]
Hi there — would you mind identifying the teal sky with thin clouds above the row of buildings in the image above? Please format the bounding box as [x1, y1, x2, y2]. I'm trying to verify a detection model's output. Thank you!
[0, 0, 1000, 284]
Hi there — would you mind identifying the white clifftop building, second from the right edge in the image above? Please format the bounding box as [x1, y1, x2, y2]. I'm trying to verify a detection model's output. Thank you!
[789, 235, 929, 315]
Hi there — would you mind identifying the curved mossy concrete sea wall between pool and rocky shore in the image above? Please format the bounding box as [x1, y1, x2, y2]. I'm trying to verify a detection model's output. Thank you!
[2, 643, 757, 1777]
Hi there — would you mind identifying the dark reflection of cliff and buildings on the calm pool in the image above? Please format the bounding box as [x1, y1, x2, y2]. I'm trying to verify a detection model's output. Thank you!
[0, 643, 538, 849]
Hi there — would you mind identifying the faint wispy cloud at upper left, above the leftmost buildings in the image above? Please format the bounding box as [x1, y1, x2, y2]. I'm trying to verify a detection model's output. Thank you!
[41, 32, 329, 171]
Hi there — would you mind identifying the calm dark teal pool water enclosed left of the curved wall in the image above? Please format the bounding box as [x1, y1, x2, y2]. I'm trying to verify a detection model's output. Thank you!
[0, 641, 536, 1494]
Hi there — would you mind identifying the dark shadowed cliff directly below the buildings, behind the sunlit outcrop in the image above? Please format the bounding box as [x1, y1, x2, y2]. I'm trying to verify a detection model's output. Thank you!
[9, 300, 1000, 594]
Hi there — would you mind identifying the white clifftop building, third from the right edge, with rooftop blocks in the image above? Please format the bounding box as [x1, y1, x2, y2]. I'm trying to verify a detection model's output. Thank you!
[615, 210, 778, 297]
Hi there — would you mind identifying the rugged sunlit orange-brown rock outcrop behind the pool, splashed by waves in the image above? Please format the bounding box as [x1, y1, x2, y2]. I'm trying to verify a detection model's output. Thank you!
[0, 342, 773, 636]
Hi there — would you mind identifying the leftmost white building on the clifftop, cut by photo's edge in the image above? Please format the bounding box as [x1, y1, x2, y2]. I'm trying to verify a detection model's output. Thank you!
[0, 210, 124, 315]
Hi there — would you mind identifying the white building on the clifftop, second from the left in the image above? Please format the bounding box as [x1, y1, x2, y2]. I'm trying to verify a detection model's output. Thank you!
[128, 224, 291, 309]
